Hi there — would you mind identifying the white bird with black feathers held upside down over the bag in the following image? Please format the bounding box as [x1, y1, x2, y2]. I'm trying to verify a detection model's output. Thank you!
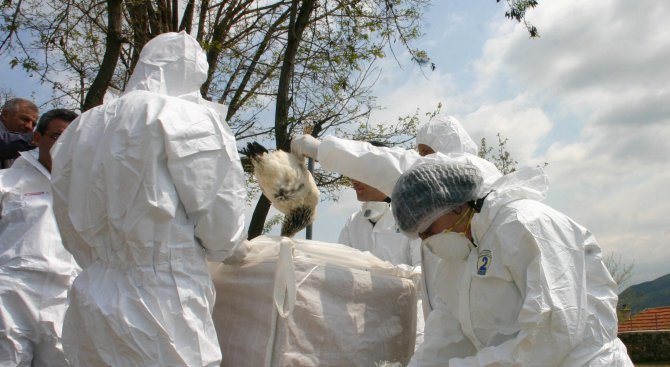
[242, 142, 319, 237]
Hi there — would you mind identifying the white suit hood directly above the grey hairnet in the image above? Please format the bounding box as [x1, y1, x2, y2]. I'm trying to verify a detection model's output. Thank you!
[416, 116, 479, 155]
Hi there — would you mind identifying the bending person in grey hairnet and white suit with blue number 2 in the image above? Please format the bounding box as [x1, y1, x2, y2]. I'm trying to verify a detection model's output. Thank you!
[392, 162, 632, 367]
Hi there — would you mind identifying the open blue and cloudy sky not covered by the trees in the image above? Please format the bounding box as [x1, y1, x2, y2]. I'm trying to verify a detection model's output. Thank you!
[0, 0, 670, 285]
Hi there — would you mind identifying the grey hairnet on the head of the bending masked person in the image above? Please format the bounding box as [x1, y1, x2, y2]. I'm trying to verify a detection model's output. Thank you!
[392, 162, 483, 237]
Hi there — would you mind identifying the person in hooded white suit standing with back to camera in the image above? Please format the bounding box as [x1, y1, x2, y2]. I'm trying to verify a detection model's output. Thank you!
[53, 32, 246, 367]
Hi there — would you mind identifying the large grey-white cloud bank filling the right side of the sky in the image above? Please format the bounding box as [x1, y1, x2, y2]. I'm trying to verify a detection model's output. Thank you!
[472, 0, 670, 283]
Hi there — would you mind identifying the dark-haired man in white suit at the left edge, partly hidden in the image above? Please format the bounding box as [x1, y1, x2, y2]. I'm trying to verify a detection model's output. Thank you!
[0, 109, 78, 367]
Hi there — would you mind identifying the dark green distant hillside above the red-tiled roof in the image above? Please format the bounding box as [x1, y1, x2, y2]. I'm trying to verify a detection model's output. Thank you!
[619, 274, 670, 315]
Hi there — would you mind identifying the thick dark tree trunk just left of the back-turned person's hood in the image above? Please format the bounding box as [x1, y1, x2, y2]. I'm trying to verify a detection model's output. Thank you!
[81, 0, 123, 112]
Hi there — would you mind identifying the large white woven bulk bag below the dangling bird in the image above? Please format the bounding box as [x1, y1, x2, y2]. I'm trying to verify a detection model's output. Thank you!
[211, 236, 417, 367]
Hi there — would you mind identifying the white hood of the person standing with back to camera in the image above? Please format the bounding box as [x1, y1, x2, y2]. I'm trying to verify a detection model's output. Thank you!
[126, 31, 209, 101]
